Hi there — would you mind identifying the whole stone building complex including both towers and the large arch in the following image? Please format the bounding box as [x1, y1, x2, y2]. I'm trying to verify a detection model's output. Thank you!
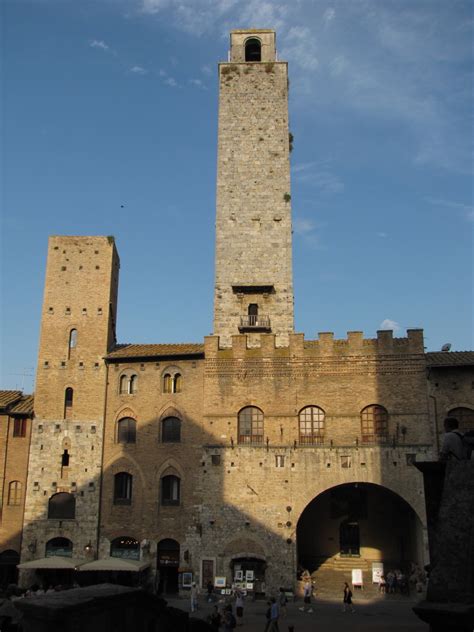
[2, 30, 474, 593]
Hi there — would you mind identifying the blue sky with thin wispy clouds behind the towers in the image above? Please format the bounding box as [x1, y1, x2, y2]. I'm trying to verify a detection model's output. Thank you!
[0, 0, 474, 391]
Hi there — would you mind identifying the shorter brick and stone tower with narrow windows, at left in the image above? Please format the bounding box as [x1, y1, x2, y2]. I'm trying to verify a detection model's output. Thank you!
[22, 236, 119, 572]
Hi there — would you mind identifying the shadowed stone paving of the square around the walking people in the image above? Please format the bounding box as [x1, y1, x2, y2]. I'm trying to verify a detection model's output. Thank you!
[168, 596, 428, 632]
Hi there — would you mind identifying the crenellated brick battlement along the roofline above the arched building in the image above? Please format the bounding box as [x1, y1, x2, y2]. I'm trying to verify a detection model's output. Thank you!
[204, 329, 424, 359]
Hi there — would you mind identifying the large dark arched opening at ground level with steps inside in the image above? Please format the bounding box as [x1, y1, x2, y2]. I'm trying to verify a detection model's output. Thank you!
[296, 483, 424, 585]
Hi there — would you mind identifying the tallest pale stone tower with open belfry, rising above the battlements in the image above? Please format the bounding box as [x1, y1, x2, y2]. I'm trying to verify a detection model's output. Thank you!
[214, 29, 293, 346]
